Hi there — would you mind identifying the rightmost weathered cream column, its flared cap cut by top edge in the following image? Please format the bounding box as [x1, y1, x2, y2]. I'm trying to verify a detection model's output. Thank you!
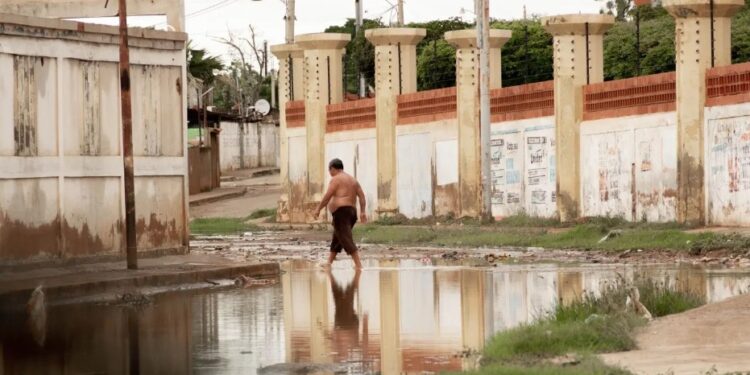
[662, 0, 745, 224]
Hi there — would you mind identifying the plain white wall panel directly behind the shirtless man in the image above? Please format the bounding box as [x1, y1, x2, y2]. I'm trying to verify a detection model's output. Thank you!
[325, 129, 378, 217]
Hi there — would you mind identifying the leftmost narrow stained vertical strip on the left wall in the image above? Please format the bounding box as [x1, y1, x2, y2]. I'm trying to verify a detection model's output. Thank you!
[13, 56, 38, 156]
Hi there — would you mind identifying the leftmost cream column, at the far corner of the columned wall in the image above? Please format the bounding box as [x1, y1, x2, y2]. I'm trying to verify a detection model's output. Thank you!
[271, 44, 303, 222]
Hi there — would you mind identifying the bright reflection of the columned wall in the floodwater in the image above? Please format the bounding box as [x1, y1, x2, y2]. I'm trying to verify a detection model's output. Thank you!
[284, 260, 750, 374]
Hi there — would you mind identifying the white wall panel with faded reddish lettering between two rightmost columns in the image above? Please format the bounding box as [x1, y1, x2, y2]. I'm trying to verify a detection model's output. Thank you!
[581, 112, 677, 222]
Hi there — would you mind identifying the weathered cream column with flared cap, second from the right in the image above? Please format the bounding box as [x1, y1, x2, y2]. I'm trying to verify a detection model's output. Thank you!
[542, 14, 614, 221]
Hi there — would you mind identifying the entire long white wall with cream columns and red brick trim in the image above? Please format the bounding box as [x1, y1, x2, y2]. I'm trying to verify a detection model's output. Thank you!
[277, 0, 750, 225]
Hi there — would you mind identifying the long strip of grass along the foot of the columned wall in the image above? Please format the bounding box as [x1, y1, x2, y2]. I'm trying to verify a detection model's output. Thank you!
[355, 223, 736, 251]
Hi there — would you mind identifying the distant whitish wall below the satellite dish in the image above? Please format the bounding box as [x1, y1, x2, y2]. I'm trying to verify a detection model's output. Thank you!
[219, 121, 279, 171]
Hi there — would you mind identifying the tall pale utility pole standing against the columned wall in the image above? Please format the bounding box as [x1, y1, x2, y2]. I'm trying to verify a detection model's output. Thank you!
[474, 0, 492, 220]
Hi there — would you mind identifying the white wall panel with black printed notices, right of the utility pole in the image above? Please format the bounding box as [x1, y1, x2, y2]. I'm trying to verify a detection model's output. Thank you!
[491, 117, 557, 218]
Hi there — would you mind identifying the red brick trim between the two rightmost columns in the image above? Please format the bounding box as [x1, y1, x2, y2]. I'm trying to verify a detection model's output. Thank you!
[583, 72, 677, 120]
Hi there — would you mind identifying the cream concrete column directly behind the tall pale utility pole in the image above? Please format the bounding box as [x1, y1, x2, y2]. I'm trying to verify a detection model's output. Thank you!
[445, 30, 511, 217]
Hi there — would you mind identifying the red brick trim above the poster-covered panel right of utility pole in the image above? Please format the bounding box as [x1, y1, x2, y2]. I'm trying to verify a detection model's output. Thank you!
[490, 81, 555, 122]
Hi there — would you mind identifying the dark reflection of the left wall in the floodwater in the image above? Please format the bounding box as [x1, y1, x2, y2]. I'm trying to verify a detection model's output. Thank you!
[0, 299, 192, 374]
